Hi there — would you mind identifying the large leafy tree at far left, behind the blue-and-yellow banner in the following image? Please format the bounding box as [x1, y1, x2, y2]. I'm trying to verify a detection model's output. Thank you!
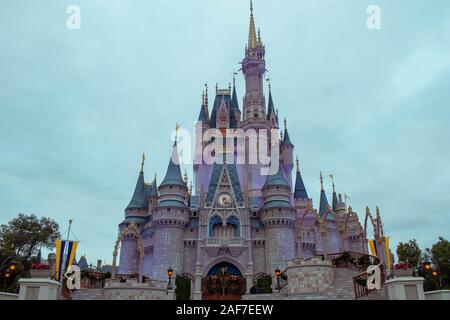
[0, 213, 60, 261]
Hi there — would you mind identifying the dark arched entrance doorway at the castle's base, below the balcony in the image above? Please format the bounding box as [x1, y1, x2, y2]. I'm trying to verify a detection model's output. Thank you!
[202, 262, 245, 300]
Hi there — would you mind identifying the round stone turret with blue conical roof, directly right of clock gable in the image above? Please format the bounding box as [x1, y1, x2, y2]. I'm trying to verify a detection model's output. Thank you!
[260, 166, 296, 273]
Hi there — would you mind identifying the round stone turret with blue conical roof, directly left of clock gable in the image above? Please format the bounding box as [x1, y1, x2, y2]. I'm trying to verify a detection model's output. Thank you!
[152, 133, 189, 280]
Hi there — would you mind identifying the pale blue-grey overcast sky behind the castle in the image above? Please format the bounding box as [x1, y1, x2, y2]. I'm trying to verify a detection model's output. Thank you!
[0, 0, 450, 262]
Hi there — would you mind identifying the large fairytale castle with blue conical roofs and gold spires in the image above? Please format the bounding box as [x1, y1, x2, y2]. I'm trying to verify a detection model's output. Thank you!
[115, 1, 367, 293]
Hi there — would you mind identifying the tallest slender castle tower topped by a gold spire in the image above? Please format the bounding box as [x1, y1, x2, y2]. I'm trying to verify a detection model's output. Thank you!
[242, 1, 266, 121]
